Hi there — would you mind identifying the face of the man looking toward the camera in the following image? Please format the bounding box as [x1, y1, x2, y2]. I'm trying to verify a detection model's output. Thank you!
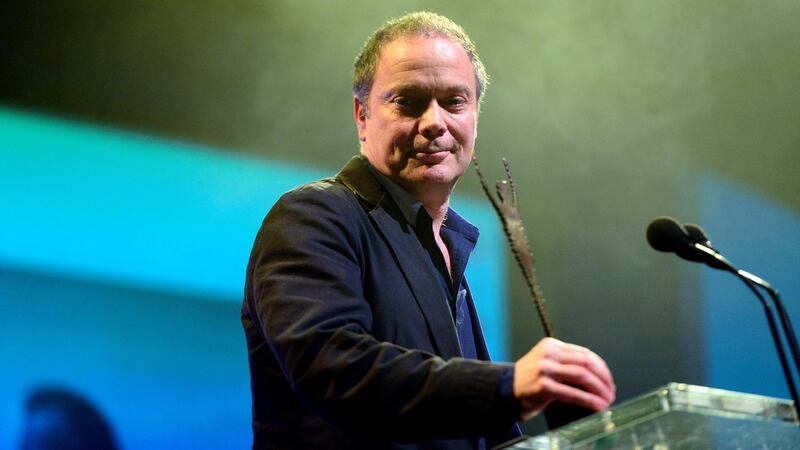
[355, 36, 477, 195]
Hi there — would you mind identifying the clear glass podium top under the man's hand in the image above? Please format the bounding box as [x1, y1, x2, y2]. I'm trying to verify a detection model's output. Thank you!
[506, 383, 800, 450]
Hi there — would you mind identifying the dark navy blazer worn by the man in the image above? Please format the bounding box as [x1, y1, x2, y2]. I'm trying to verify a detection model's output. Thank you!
[242, 157, 518, 449]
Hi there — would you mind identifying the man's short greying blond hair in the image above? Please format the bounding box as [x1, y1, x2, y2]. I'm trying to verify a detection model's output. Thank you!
[353, 11, 489, 107]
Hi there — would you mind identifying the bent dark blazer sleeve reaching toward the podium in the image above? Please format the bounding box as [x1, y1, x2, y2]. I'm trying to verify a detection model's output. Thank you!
[248, 185, 517, 440]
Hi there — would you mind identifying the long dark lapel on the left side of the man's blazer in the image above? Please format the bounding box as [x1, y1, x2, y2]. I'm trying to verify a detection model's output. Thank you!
[337, 157, 461, 359]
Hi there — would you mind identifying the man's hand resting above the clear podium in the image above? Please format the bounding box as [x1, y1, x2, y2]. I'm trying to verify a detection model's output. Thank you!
[514, 338, 617, 420]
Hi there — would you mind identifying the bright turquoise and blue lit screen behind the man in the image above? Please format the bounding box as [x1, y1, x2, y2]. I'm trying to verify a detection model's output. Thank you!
[0, 109, 510, 449]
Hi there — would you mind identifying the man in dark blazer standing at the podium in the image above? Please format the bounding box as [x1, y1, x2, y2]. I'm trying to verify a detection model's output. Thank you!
[242, 13, 615, 449]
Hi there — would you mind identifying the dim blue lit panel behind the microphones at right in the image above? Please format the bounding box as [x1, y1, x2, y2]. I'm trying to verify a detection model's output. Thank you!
[701, 178, 800, 398]
